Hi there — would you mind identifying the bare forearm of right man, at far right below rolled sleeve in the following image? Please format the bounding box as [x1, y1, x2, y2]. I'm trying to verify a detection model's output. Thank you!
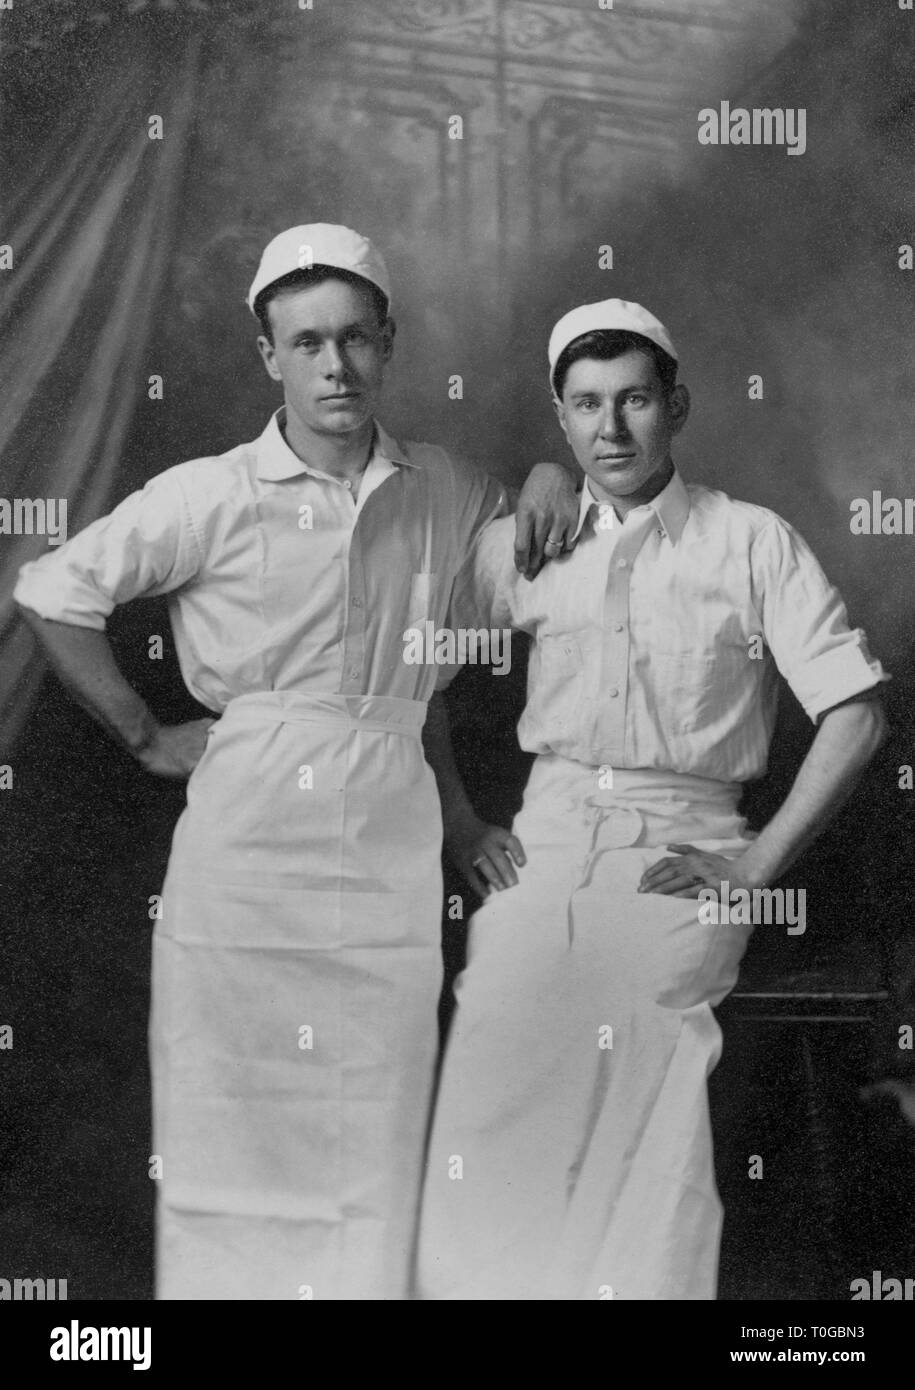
[741, 701, 886, 884]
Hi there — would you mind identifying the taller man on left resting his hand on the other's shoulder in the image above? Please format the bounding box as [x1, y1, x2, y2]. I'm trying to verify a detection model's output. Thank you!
[17, 224, 577, 1300]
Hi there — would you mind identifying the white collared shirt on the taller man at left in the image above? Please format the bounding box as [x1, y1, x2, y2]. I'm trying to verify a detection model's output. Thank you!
[15, 410, 513, 710]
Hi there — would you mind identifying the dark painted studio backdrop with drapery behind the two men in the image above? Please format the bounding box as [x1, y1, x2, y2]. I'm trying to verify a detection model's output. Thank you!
[0, 0, 915, 1298]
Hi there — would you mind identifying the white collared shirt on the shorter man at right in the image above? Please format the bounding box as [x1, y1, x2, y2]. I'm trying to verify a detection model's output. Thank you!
[451, 471, 889, 783]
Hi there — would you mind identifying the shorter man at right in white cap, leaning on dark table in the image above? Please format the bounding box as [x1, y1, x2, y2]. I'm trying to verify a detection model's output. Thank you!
[419, 300, 886, 1300]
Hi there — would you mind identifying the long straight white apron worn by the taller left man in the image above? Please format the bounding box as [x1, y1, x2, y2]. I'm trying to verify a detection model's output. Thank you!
[150, 692, 442, 1300]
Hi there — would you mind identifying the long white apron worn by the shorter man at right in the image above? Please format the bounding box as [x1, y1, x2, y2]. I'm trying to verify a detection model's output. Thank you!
[419, 756, 751, 1300]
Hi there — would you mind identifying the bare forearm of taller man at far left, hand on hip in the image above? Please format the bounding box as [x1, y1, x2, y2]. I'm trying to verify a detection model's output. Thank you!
[19, 606, 159, 753]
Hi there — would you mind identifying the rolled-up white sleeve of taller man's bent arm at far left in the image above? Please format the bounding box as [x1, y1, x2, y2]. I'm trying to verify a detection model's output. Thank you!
[13, 466, 202, 630]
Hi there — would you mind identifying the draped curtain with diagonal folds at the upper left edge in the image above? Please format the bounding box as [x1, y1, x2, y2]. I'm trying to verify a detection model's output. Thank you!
[0, 4, 214, 749]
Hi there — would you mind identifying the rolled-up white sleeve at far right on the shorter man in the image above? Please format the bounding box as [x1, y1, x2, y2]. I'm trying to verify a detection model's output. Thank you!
[751, 517, 890, 721]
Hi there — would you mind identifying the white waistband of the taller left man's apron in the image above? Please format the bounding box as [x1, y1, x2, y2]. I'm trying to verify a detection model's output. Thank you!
[214, 691, 426, 739]
